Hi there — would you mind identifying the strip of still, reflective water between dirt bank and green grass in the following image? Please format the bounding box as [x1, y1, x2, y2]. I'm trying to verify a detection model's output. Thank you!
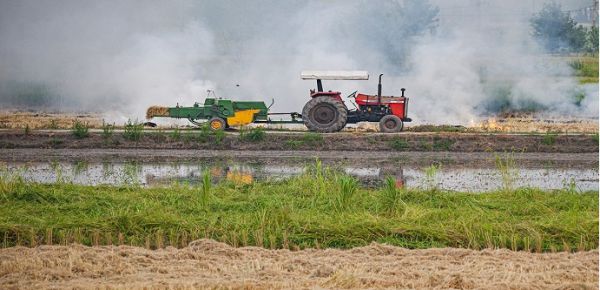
[6, 162, 599, 191]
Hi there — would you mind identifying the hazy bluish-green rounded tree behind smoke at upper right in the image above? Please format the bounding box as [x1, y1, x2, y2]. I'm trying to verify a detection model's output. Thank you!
[531, 2, 587, 53]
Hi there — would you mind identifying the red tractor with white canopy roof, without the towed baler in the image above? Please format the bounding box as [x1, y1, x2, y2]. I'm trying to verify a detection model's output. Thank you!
[302, 71, 411, 133]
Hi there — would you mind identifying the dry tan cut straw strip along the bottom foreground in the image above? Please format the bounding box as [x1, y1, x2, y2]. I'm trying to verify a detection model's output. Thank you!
[0, 240, 598, 289]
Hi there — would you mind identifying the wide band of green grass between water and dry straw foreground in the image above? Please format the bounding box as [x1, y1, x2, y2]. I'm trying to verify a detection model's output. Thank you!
[0, 170, 598, 252]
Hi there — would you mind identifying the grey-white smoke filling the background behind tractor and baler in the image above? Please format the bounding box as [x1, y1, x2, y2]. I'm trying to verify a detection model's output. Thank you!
[0, 0, 598, 124]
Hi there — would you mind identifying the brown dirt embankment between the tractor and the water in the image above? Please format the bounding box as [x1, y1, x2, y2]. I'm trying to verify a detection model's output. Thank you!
[0, 130, 598, 153]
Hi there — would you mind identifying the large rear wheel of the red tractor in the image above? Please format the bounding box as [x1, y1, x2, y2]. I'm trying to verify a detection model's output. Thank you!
[302, 96, 348, 133]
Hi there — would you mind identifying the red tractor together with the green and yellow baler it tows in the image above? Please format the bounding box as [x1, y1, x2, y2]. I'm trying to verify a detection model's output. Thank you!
[146, 71, 411, 133]
